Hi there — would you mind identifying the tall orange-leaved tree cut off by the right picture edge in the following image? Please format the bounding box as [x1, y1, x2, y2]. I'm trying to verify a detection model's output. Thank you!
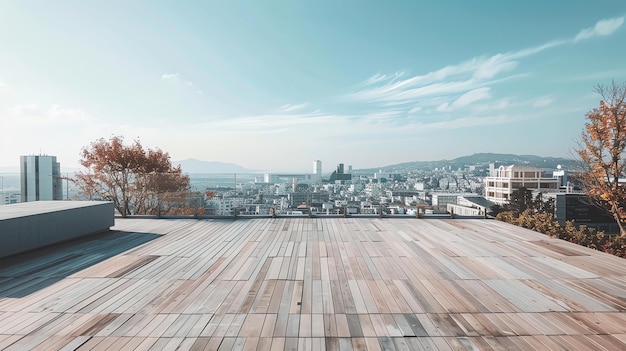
[576, 82, 626, 237]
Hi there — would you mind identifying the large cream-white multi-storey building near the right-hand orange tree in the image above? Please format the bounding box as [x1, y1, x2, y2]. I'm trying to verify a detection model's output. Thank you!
[485, 165, 560, 205]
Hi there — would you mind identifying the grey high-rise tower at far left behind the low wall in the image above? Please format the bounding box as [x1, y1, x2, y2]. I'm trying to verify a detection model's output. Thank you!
[20, 155, 63, 202]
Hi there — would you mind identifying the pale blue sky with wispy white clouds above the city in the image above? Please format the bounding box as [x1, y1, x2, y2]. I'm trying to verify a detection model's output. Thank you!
[0, 0, 626, 171]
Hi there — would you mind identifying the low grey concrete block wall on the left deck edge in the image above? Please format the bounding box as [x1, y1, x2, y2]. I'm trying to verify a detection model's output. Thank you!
[0, 201, 115, 257]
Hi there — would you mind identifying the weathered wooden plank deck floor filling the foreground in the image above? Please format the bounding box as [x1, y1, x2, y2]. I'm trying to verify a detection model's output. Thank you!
[0, 218, 626, 350]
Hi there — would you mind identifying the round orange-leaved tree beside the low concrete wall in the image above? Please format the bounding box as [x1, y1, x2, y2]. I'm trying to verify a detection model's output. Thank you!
[76, 136, 189, 217]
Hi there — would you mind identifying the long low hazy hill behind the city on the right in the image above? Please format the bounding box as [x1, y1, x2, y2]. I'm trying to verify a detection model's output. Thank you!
[359, 153, 574, 172]
